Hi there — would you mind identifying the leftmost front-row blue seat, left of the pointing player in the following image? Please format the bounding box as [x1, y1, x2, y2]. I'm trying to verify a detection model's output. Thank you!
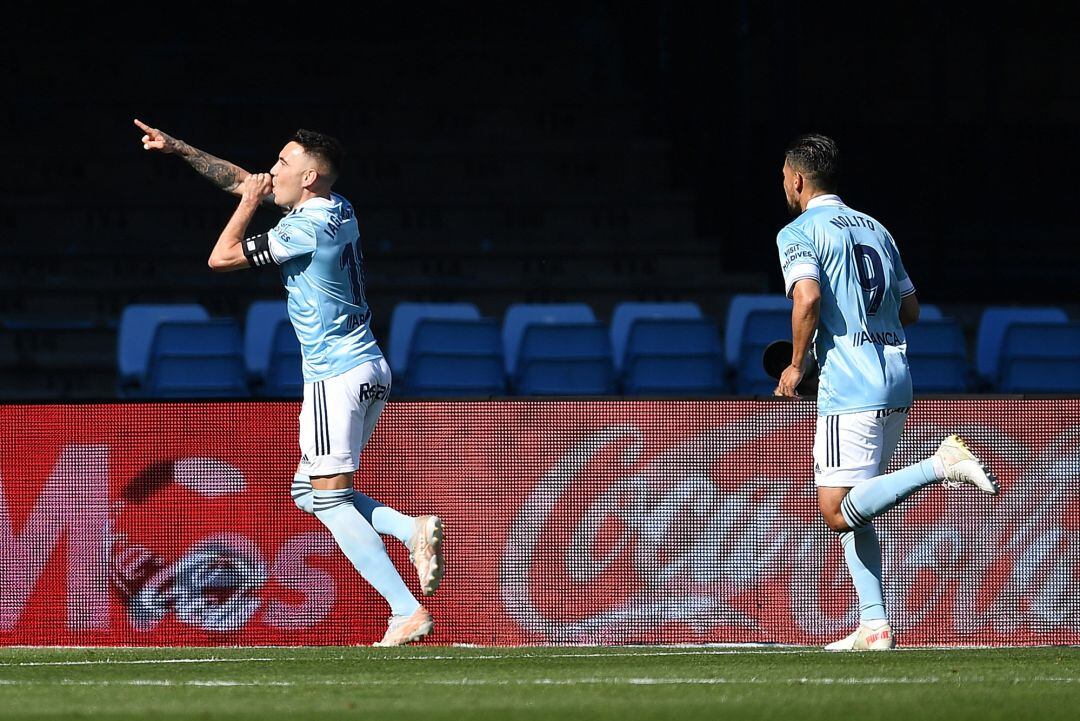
[147, 321, 247, 398]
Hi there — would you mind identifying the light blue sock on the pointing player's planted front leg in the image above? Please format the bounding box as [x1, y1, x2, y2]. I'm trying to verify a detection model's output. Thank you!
[313, 488, 420, 616]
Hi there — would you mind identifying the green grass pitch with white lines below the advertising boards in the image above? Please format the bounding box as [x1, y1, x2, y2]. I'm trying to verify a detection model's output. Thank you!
[0, 647, 1080, 721]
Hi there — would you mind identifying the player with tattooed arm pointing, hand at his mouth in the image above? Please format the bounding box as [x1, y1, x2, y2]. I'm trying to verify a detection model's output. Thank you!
[135, 120, 445, 645]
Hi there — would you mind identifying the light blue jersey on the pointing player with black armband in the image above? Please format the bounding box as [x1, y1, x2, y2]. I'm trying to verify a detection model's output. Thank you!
[267, 193, 382, 383]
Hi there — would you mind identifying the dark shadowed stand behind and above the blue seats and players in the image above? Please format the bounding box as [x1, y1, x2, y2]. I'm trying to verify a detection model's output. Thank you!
[0, 0, 1080, 398]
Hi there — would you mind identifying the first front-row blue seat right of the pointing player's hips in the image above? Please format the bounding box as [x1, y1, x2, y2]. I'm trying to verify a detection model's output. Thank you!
[403, 318, 507, 396]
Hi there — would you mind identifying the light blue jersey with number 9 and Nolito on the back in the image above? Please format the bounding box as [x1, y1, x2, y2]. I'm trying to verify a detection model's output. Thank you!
[777, 195, 915, 416]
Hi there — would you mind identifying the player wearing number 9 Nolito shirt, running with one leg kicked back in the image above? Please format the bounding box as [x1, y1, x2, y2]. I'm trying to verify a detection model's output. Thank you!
[774, 135, 998, 651]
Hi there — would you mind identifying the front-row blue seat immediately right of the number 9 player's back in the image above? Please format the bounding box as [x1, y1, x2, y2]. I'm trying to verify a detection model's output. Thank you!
[904, 318, 969, 393]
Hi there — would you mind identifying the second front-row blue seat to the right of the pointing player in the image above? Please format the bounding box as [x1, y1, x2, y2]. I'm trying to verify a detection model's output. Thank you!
[513, 323, 616, 395]
